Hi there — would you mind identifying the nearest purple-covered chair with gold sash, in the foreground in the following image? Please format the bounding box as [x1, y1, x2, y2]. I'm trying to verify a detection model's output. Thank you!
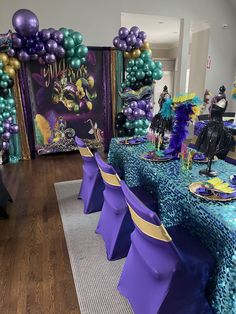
[118, 181, 214, 314]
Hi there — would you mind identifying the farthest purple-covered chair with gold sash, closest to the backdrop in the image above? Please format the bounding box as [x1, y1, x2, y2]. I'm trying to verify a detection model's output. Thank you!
[75, 137, 104, 214]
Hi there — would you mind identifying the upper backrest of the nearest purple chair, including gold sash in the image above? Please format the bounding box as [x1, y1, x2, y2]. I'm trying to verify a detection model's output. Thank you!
[121, 181, 173, 245]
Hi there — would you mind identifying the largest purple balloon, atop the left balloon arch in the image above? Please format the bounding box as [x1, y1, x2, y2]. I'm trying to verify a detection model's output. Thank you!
[12, 9, 39, 37]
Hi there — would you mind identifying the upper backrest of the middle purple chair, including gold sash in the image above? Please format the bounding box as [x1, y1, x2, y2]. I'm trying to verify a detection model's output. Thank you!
[95, 153, 121, 190]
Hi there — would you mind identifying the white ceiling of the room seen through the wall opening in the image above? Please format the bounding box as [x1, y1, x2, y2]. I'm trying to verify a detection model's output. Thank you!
[121, 13, 210, 48]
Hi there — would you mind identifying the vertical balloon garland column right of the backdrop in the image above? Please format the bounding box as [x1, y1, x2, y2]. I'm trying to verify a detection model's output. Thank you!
[113, 26, 163, 136]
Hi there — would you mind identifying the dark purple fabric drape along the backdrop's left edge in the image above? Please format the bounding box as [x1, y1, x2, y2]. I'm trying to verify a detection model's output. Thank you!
[19, 63, 35, 158]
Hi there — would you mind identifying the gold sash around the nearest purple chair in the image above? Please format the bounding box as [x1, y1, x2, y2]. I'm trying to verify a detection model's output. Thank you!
[128, 204, 172, 242]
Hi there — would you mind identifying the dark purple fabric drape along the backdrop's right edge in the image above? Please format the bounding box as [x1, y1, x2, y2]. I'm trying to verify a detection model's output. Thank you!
[102, 48, 113, 152]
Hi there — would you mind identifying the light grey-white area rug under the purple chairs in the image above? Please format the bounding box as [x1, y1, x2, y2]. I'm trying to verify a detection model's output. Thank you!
[55, 180, 133, 314]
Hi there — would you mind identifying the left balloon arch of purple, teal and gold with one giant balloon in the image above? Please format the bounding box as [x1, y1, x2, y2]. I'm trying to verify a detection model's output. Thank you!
[0, 9, 88, 151]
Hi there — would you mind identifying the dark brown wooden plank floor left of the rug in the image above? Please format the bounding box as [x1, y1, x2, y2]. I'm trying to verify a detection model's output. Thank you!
[0, 153, 82, 314]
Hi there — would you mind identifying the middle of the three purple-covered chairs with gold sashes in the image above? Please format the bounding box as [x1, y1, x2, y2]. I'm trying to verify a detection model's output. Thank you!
[95, 153, 158, 260]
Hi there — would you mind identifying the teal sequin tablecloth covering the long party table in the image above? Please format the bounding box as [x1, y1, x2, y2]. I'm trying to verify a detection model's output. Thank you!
[108, 138, 236, 314]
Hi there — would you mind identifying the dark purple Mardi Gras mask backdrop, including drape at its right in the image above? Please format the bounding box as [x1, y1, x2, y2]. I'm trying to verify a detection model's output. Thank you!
[29, 48, 112, 154]
